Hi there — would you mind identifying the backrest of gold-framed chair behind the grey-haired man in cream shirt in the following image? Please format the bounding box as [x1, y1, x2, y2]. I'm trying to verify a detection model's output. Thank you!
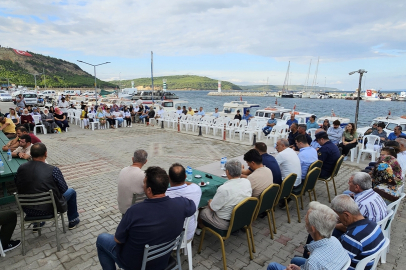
[226, 197, 258, 238]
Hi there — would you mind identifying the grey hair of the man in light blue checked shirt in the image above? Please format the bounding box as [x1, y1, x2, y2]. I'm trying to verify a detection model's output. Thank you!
[307, 201, 338, 238]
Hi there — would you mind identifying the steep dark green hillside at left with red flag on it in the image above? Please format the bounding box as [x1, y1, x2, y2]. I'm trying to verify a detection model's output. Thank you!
[0, 48, 116, 88]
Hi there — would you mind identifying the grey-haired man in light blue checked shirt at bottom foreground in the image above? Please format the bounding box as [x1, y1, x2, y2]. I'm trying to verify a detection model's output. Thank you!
[267, 202, 349, 270]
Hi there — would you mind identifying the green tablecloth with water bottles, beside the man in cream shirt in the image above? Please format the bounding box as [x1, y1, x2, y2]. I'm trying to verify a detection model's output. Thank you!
[191, 170, 227, 208]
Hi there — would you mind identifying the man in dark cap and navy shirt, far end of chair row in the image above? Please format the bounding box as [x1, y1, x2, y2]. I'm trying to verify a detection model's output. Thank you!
[316, 131, 341, 179]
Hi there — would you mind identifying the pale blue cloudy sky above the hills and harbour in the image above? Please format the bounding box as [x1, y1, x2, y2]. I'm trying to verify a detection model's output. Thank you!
[0, 0, 406, 91]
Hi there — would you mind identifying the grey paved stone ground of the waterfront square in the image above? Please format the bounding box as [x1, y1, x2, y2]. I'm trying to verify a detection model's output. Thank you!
[0, 104, 406, 270]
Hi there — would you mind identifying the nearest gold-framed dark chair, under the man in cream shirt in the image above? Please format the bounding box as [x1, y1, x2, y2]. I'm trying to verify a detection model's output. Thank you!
[197, 197, 258, 270]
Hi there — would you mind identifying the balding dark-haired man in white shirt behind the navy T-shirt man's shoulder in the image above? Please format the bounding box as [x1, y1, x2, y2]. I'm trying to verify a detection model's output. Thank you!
[165, 163, 202, 241]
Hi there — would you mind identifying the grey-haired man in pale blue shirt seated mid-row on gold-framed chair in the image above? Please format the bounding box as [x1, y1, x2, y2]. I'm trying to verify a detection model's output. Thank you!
[275, 139, 302, 209]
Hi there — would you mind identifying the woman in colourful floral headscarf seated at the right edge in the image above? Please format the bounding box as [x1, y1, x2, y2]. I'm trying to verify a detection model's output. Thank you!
[371, 147, 403, 203]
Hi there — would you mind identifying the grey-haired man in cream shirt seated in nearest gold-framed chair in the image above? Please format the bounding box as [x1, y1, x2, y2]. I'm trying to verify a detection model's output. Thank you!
[199, 160, 252, 230]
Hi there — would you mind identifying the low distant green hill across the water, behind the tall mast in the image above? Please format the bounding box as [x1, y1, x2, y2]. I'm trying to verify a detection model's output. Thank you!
[111, 75, 241, 91]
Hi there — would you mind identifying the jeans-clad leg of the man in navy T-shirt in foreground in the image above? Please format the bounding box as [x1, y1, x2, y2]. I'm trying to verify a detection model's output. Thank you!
[96, 233, 123, 270]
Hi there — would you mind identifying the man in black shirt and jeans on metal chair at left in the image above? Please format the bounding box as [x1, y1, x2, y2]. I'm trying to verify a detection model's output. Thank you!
[14, 142, 80, 230]
